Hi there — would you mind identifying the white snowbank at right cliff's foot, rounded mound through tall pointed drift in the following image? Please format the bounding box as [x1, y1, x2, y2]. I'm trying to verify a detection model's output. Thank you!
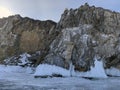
[34, 60, 107, 78]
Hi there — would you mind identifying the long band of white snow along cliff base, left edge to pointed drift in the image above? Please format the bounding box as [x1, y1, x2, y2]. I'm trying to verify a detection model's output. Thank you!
[0, 60, 108, 78]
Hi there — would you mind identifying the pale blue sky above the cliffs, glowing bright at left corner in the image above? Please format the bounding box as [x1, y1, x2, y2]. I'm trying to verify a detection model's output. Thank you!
[0, 0, 120, 22]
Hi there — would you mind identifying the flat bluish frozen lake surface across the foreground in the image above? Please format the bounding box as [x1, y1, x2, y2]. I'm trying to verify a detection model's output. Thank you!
[0, 72, 120, 90]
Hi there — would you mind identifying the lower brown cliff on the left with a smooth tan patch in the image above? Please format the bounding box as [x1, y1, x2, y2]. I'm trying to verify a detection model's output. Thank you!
[0, 15, 56, 63]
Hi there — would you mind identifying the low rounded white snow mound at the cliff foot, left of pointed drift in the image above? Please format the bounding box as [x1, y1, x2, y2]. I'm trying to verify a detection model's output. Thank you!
[34, 64, 70, 76]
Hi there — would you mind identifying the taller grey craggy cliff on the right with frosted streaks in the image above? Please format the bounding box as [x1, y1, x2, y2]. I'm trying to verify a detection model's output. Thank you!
[43, 4, 120, 71]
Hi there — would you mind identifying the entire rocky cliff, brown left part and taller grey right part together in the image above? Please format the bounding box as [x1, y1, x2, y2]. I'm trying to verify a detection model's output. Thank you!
[0, 3, 120, 71]
